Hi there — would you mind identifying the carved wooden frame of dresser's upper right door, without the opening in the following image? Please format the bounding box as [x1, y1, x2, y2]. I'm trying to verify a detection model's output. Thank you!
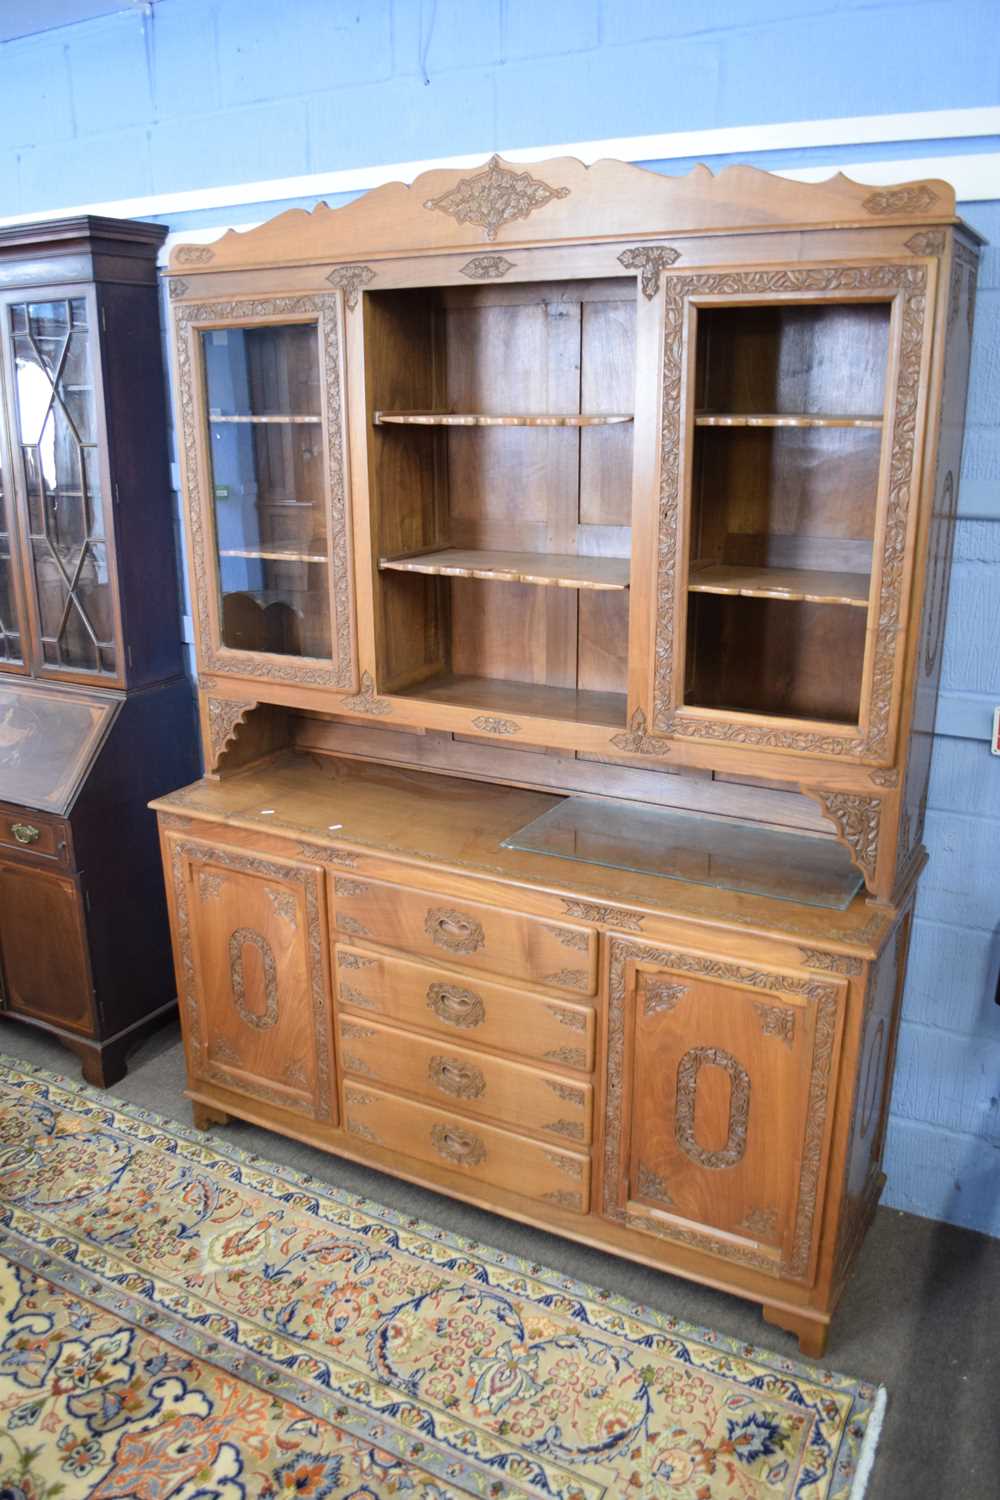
[648, 261, 937, 767]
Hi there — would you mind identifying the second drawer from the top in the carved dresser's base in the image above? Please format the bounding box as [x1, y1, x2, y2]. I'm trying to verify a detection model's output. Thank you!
[336, 944, 595, 1073]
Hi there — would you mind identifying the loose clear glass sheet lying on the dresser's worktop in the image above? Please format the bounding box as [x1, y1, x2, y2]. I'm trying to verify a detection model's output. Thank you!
[502, 797, 862, 912]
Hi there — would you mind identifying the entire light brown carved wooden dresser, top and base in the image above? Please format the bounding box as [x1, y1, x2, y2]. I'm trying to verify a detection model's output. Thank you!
[156, 158, 979, 1355]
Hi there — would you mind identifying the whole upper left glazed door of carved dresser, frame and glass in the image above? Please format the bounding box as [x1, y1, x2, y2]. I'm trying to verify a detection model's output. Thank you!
[174, 291, 357, 692]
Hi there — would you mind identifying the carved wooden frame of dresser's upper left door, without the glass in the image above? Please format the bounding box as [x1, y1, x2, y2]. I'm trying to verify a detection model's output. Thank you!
[174, 291, 358, 693]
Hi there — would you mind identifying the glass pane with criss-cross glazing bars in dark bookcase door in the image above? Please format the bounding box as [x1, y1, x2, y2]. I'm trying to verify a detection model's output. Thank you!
[10, 297, 117, 674]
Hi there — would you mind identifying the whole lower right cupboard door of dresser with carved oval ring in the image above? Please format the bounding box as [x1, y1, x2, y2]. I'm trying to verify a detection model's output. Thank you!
[604, 938, 846, 1281]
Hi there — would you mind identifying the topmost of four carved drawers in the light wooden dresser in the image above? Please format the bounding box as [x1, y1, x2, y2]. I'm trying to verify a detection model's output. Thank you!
[333, 875, 597, 995]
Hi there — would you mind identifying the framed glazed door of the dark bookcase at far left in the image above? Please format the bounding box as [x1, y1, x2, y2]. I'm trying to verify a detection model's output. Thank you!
[0, 287, 123, 687]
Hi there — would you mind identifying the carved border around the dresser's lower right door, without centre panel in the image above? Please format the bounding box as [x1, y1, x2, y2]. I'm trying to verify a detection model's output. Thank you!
[603, 935, 843, 1280]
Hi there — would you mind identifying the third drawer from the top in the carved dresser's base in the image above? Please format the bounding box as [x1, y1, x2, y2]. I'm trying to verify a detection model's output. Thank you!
[340, 1016, 594, 1146]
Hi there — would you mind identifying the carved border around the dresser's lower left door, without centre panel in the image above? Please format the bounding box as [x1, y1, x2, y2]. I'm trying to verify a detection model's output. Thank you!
[171, 839, 333, 1121]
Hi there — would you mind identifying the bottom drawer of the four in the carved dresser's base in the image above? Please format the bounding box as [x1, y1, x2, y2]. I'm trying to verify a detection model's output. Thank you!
[343, 1080, 591, 1214]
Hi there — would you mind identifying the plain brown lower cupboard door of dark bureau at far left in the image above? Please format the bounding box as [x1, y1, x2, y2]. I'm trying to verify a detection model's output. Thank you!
[0, 863, 94, 1035]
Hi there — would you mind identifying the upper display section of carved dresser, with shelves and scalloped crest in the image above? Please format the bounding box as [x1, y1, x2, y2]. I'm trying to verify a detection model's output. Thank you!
[168, 158, 979, 899]
